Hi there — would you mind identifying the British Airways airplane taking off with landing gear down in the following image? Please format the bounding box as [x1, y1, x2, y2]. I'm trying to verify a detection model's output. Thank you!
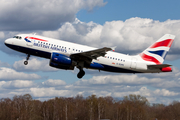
[5, 34, 175, 79]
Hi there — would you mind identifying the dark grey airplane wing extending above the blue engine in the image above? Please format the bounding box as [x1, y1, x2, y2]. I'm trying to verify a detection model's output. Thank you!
[70, 47, 112, 63]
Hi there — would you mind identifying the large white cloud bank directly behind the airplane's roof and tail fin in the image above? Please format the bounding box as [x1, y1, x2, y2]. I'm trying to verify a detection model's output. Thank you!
[42, 17, 180, 60]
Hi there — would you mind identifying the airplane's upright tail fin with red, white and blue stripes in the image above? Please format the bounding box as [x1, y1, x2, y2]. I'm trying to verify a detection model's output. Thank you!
[139, 34, 175, 64]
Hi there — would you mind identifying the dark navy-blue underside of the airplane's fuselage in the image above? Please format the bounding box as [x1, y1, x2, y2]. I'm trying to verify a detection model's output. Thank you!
[6, 44, 140, 73]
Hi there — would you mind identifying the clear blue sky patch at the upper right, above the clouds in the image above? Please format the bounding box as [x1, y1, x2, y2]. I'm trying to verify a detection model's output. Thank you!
[77, 0, 180, 24]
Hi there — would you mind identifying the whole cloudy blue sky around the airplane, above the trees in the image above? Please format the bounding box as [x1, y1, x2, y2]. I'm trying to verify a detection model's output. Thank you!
[0, 0, 180, 104]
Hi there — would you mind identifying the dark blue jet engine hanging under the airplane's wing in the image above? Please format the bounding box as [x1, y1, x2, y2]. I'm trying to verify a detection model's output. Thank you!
[49, 53, 74, 70]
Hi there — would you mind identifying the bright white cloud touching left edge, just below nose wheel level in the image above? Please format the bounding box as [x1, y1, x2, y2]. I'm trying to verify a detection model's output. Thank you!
[0, 67, 41, 80]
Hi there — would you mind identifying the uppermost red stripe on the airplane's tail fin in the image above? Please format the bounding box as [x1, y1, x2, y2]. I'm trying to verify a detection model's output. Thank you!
[150, 39, 173, 48]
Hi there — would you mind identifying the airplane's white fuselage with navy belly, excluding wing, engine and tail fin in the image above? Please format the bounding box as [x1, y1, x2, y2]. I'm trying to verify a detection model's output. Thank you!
[5, 34, 165, 73]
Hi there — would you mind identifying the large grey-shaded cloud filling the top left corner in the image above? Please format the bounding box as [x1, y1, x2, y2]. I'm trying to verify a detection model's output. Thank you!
[0, 0, 106, 30]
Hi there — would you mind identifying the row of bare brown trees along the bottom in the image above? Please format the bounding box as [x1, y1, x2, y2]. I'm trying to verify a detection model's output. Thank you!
[0, 94, 180, 120]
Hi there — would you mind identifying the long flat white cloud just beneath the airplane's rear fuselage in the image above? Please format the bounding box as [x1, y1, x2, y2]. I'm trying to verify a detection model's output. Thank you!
[75, 74, 163, 86]
